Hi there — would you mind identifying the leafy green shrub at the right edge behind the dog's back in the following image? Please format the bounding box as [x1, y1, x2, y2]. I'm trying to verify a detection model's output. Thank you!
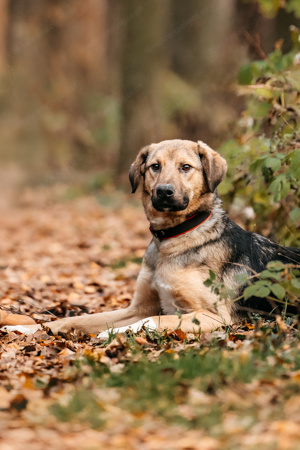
[219, 27, 300, 246]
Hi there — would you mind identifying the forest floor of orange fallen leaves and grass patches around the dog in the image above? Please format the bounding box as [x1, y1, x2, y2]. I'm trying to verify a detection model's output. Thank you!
[0, 186, 300, 450]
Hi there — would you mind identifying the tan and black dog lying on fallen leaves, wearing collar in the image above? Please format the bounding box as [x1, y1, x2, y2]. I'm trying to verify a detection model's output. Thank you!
[0, 139, 300, 338]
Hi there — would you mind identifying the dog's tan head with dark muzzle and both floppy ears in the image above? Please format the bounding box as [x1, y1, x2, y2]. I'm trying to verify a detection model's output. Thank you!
[129, 139, 227, 224]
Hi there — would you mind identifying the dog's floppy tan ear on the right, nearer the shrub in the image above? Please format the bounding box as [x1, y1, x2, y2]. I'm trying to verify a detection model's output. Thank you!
[198, 141, 227, 192]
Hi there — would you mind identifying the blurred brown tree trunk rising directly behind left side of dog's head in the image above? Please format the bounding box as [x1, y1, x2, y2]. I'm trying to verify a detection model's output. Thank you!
[118, 0, 168, 178]
